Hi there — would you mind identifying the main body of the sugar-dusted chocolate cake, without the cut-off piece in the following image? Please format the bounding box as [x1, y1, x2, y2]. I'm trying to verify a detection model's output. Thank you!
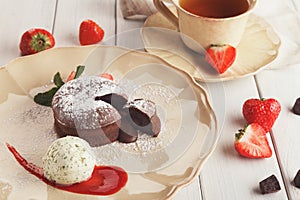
[52, 76, 127, 146]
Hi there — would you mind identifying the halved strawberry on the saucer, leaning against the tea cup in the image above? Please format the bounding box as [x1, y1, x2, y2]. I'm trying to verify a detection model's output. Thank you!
[205, 44, 236, 74]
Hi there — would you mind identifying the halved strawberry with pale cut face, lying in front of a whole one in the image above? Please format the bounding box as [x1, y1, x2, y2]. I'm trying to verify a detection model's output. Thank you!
[234, 123, 272, 158]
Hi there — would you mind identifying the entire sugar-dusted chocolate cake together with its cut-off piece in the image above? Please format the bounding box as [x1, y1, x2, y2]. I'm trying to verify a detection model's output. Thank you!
[52, 76, 161, 146]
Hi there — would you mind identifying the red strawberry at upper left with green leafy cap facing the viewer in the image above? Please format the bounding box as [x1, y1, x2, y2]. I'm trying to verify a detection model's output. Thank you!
[19, 28, 55, 56]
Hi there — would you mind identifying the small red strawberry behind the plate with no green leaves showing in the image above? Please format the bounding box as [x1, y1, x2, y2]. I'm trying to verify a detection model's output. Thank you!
[79, 19, 104, 45]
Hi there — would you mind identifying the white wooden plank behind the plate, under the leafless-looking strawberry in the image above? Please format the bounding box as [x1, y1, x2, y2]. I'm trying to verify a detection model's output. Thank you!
[54, 0, 115, 47]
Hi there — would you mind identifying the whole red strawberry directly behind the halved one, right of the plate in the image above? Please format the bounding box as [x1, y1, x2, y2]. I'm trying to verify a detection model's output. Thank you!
[243, 98, 281, 133]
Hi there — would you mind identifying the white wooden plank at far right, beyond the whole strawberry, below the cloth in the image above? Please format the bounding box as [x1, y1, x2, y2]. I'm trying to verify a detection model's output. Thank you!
[257, 65, 300, 199]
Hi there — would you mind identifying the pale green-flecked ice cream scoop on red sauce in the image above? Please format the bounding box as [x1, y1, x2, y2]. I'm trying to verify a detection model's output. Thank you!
[43, 136, 96, 185]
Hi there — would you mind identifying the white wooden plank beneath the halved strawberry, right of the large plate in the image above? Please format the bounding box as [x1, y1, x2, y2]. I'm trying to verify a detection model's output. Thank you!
[200, 77, 287, 200]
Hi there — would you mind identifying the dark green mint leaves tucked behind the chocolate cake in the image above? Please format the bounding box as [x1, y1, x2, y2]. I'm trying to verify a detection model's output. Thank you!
[33, 65, 85, 107]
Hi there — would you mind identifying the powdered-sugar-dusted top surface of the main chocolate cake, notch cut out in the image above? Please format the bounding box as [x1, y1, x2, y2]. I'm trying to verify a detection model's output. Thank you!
[52, 76, 124, 129]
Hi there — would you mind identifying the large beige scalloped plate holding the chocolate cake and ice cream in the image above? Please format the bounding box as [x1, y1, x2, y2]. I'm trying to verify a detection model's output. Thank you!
[0, 46, 219, 200]
